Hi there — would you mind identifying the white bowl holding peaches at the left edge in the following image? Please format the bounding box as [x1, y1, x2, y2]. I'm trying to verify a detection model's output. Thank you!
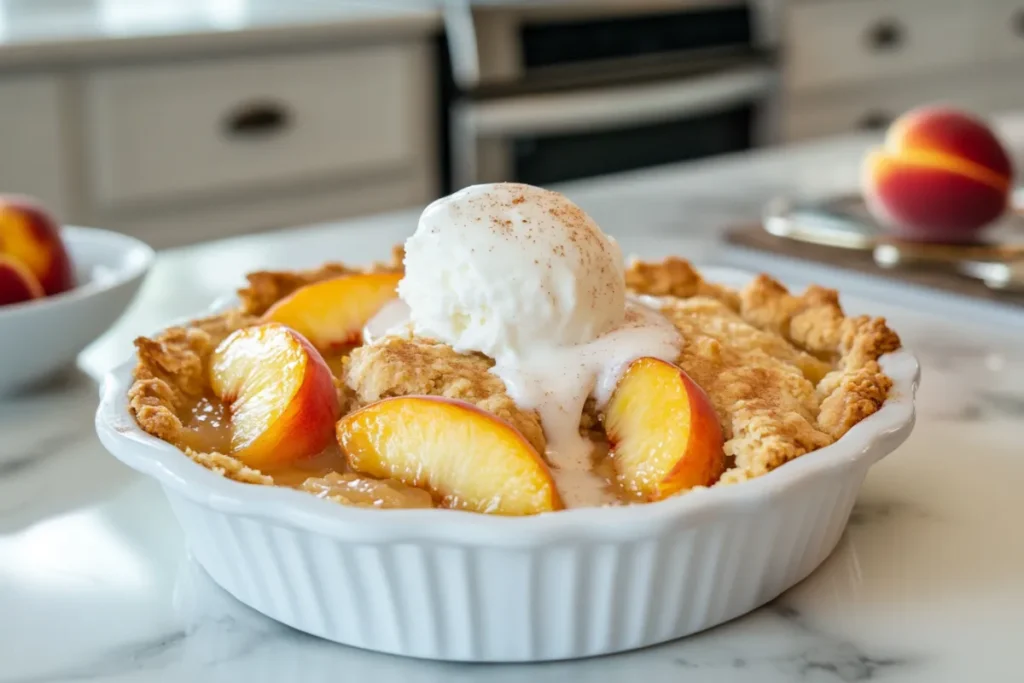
[0, 227, 154, 394]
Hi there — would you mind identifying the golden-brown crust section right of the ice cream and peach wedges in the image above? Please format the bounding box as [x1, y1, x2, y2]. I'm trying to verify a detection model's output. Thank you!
[627, 258, 900, 484]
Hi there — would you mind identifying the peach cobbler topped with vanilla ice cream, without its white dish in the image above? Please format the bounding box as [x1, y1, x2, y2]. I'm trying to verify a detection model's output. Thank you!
[130, 183, 900, 515]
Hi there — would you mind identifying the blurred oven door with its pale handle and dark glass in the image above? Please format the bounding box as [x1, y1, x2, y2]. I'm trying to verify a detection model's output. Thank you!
[450, 54, 778, 187]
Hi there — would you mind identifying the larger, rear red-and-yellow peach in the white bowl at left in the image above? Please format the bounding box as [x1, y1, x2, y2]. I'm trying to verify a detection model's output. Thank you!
[0, 196, 75, 296]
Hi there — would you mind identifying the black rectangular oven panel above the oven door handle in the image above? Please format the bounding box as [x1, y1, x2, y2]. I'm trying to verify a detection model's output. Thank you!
[519, 3, 753, 71]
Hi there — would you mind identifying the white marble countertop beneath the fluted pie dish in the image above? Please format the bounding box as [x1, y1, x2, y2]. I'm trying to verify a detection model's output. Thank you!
[0, 135, 1024, 683]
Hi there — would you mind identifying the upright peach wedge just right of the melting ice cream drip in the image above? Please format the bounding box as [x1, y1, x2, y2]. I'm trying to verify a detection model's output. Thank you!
[604, 357, 725, 501]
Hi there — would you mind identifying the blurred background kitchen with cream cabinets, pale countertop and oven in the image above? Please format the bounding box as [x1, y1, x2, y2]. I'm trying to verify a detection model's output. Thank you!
[0, 0, 1024, 248]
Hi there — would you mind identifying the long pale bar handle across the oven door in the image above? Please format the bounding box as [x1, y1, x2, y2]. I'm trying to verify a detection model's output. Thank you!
[453, 66, 778, 139]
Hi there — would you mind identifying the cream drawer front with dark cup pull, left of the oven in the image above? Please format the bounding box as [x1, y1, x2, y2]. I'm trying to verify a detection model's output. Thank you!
[85, 44, 423, 207]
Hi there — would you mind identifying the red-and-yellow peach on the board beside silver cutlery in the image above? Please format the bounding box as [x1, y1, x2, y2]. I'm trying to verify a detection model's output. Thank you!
[862, 108, 1014, 243]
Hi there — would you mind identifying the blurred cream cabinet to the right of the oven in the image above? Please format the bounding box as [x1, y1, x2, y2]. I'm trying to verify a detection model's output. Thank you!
[782, 0, 1024, 141]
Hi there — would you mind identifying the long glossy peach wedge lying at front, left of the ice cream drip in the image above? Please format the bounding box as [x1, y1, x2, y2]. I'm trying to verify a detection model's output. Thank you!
[337, 396, 562, 515]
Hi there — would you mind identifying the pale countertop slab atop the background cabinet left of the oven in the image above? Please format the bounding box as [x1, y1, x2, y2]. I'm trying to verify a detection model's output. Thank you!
[0, 0, 440, 68]
